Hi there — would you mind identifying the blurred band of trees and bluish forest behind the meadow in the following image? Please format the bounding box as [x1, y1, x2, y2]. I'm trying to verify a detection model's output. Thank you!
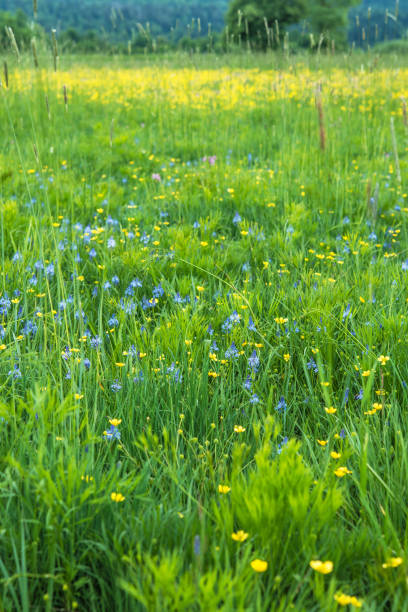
[0, 0, 408, 53]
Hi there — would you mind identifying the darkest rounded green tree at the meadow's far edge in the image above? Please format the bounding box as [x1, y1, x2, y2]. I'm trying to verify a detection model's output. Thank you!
[226, 0, 309, 48]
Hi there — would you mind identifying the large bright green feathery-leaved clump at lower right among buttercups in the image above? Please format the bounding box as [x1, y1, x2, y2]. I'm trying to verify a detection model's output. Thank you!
[216, 420, 342, 586]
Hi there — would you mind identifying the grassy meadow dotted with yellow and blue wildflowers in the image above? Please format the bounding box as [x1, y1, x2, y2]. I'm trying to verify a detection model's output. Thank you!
[0, 50, 408, 612]
